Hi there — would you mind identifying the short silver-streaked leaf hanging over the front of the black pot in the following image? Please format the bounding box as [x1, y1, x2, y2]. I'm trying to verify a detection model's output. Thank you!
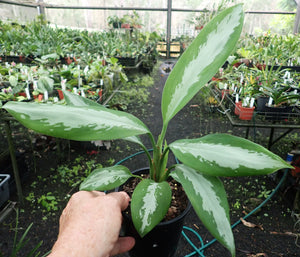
[131, 179, 172, 237]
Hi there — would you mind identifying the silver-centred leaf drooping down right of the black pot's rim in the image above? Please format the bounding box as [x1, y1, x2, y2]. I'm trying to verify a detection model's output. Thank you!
[170, 164, 235, 256]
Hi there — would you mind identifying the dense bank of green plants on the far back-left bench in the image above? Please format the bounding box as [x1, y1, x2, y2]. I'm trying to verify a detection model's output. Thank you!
[0, 19, 159, 61]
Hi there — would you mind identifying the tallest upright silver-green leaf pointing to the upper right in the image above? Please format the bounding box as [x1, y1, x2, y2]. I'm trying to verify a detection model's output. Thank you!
[161, 5, 244, 127]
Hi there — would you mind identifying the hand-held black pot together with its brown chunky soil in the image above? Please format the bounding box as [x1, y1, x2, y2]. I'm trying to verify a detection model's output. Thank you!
[117, 168, 191, 257]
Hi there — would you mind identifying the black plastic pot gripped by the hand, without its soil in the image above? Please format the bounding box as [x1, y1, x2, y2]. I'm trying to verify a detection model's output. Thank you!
[118, 168, 191, 257]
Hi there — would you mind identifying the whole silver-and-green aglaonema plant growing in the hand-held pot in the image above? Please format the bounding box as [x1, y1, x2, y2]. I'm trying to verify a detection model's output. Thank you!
[4, 5, 291, 256]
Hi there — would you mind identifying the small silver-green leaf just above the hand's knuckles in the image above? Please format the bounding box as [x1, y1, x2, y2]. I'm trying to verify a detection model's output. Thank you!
[79, 165, 132, 191]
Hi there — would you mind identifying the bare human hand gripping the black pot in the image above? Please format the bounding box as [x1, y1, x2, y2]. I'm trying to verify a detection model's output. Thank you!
[49, 191, 135, 257]
